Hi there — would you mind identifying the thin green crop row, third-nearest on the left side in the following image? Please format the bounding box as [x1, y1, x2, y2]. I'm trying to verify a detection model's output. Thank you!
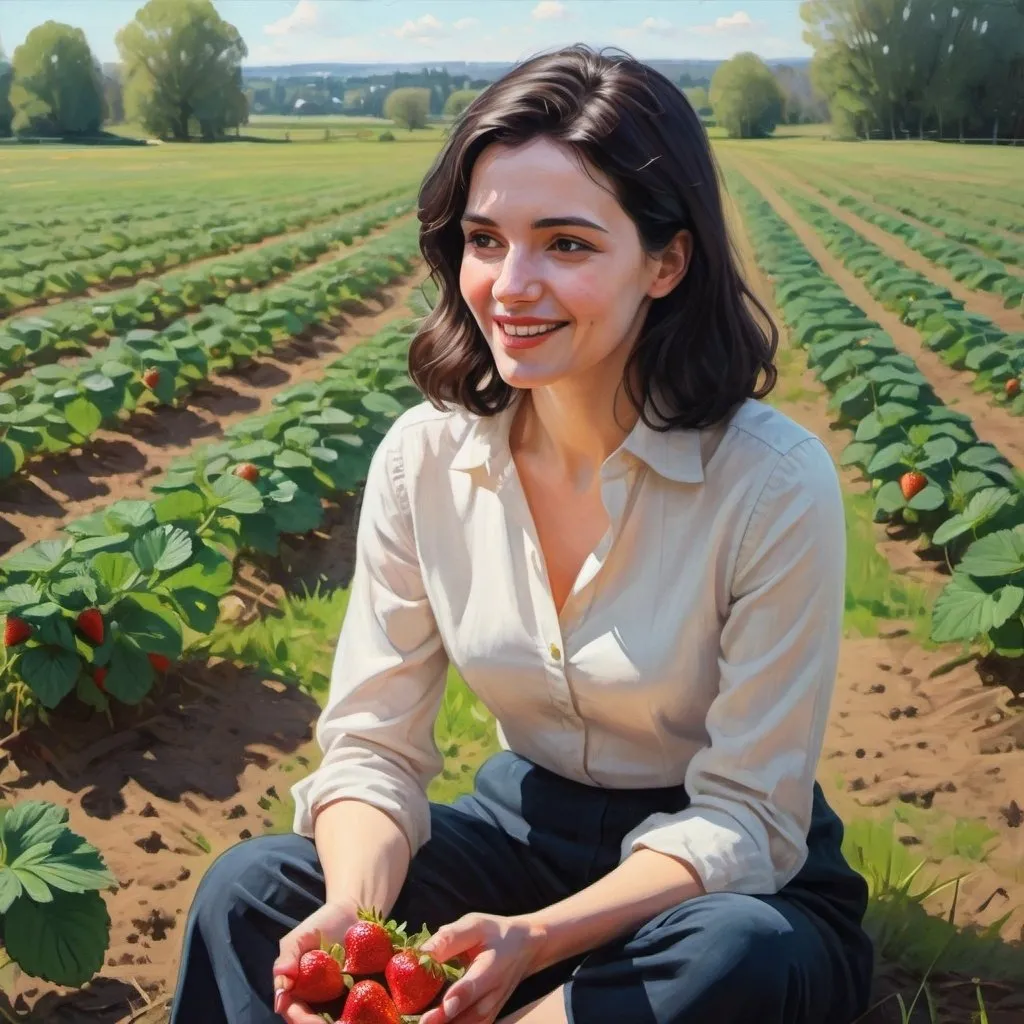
[0, 187, 415, 313]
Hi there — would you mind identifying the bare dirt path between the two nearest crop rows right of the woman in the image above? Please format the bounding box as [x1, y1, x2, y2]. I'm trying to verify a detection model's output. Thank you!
[724, 164, 1024, 470]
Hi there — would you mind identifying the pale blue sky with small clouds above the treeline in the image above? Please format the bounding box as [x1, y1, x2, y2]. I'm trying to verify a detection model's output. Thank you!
[0, 0, 811, 65]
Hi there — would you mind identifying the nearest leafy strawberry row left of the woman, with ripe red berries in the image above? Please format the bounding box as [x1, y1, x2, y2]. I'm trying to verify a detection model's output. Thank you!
[0, 321, 419, 712]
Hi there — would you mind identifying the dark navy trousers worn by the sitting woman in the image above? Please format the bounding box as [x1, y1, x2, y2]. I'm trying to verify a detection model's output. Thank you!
[171, 753, 873, 1024]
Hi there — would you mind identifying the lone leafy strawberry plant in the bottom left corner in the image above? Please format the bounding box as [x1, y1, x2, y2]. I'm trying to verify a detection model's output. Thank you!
[0, 800, 117, 986]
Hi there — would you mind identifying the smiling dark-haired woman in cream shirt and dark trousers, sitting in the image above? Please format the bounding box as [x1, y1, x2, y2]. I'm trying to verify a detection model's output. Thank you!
[172, 46, 872, 1024]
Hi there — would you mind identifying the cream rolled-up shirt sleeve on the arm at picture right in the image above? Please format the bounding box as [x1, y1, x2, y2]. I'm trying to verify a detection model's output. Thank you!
[623, 437, 847, 894]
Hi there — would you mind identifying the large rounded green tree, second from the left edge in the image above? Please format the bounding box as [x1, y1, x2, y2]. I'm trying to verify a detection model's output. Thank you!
[117, 0, 249, 141]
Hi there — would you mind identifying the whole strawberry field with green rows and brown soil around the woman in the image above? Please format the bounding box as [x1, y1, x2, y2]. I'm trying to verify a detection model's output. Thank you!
[0, 134, 1024, 1024]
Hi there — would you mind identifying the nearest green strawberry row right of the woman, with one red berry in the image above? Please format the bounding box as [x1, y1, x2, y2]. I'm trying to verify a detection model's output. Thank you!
[729, 171, 1024, 658]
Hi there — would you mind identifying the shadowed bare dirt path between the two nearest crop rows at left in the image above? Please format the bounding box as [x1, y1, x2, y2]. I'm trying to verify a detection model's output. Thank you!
[0, 268, 420, 556]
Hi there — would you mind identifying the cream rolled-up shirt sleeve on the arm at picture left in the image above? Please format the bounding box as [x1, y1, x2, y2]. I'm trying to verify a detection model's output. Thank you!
[292, 419, 449, 853]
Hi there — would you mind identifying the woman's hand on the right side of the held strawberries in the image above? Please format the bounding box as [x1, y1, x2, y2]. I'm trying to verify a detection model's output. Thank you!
[420, 913, 542, 1024]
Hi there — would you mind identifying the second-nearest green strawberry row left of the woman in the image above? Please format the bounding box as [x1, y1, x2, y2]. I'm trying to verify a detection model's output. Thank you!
[0, 202, 416, 479]
